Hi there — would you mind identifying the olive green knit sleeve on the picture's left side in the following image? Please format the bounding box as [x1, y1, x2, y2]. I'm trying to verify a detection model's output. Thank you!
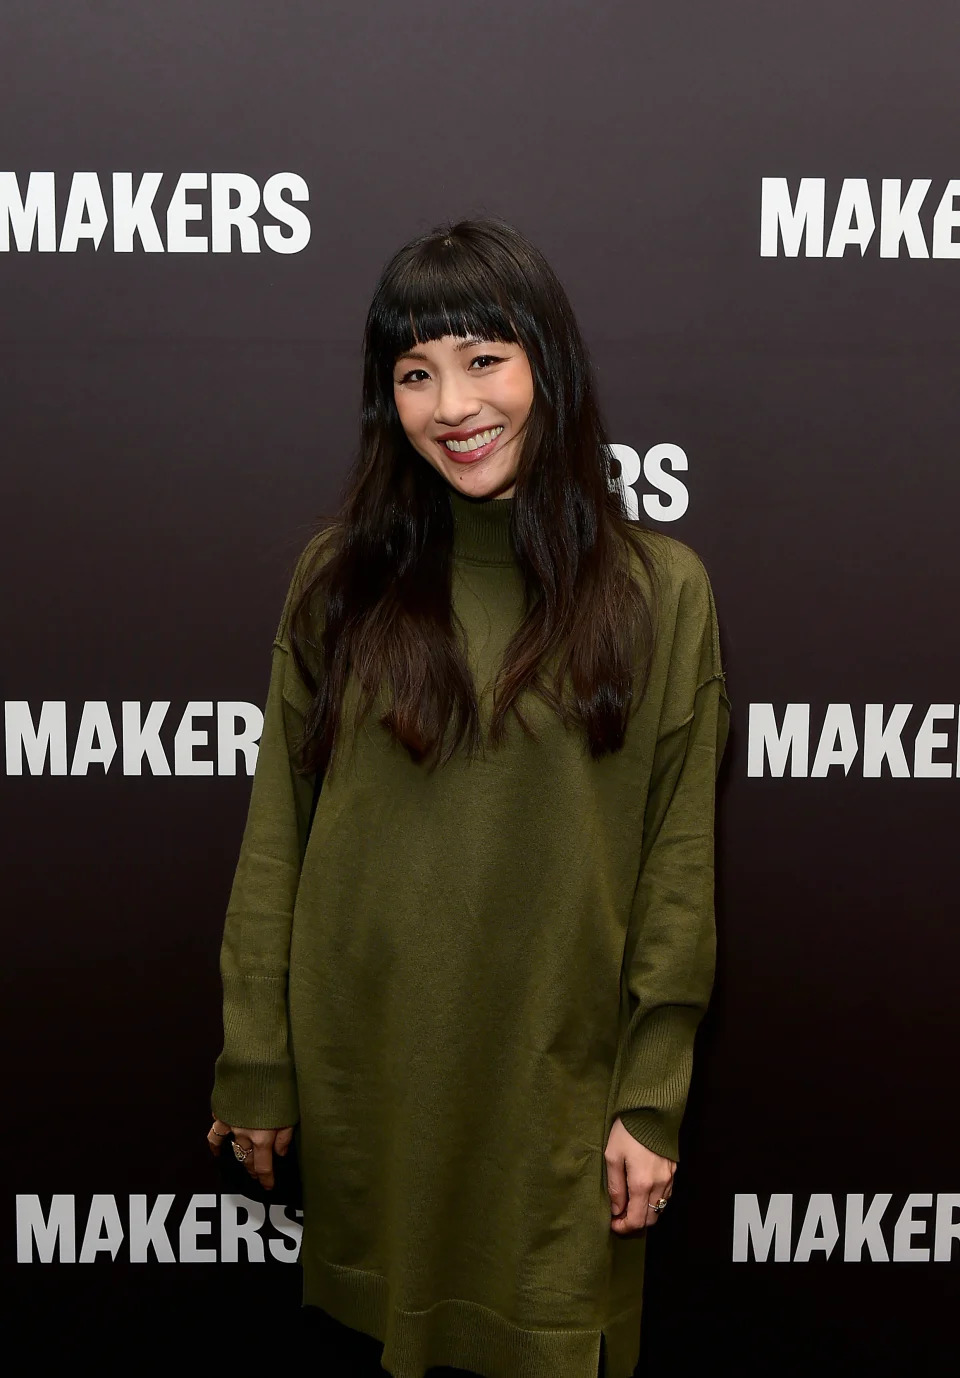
[211, 531, 327, 1129]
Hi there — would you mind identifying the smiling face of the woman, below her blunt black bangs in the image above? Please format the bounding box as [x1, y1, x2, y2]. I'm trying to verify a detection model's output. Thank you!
[394, 335, 533, 497]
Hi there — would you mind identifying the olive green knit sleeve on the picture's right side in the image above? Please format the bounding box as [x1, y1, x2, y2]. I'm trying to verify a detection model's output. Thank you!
[614, 548, 730, 1162]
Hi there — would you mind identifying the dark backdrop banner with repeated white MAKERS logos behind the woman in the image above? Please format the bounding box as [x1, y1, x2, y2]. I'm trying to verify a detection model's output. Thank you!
[0, 0, 960, 1378]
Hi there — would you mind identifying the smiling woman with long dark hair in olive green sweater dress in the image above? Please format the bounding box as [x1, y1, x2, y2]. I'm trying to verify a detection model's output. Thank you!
[209, 219, 730, 1378]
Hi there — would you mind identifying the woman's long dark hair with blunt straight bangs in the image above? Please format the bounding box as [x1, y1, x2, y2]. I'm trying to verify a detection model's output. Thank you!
[289, 218, 657, 773]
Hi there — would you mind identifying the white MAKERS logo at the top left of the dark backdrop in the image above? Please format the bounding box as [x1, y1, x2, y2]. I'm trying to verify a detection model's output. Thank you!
[0, 172, 310, 254]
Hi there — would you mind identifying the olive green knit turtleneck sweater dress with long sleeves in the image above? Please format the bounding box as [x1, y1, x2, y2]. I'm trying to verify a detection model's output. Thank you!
[212, 489, 730, 1378]
